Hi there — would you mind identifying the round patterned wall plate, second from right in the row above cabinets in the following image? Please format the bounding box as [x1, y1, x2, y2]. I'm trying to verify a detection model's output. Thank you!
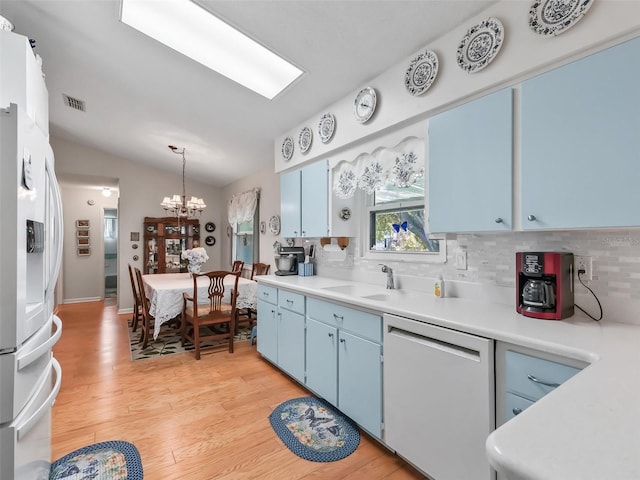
[457, 17, 504, 73]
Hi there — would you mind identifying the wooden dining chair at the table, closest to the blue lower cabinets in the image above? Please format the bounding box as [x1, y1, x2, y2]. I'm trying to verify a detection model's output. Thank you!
[182, 271, 240, 360]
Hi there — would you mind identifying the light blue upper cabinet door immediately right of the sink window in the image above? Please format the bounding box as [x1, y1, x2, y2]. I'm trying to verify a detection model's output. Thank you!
[427, 89, 513, 233]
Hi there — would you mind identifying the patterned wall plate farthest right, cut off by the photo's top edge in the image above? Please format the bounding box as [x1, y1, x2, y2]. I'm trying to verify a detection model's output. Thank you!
[529, 0, 593, 35]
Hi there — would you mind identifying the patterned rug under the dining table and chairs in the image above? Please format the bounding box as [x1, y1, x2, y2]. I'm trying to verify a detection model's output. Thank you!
[129, 325, 251, 361]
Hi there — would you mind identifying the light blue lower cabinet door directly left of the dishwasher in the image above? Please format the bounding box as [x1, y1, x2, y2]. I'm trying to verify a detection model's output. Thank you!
[338, 331, 382, 438]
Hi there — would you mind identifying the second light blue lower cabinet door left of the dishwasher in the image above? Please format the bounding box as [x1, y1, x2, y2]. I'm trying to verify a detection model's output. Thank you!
[306, 318, 338, 405]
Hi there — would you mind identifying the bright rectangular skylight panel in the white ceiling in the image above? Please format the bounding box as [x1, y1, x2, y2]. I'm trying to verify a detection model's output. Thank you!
[120, 0, 302, 100]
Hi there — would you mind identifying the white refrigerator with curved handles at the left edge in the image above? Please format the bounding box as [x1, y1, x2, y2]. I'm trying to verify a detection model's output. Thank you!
[0, 32, 63, 480]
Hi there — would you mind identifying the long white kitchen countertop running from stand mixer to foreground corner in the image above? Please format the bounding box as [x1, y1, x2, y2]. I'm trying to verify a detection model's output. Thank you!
[256, 275, 640, 480]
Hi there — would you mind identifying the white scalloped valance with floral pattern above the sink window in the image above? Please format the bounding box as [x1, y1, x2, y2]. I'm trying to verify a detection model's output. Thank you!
[333, 137, 426, 199]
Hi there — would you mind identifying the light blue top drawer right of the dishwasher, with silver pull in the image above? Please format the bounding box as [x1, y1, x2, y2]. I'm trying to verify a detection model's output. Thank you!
[505, 351, 580, 401]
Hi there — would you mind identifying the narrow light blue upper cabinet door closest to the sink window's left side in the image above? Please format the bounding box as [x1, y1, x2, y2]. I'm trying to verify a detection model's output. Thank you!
[301, 160, 329, 237]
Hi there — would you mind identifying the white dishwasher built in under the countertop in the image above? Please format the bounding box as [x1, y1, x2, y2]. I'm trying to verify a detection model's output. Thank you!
[383, 314, 495, 480]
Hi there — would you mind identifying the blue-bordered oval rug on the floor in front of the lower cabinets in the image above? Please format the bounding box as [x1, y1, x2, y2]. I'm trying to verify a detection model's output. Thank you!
[269, 397, 360, 462]
